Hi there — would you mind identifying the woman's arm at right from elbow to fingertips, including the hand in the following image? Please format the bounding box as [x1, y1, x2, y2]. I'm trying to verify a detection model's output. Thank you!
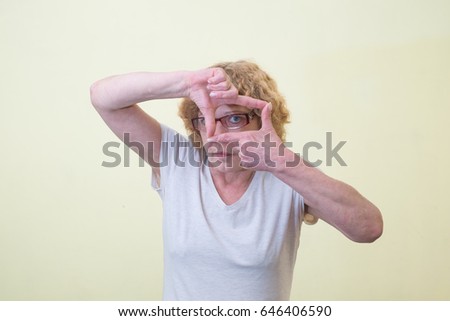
[210, 104, 383, 242]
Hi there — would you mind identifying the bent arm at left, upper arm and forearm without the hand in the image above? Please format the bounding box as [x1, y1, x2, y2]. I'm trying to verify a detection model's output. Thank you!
[91, 72, 189, 168]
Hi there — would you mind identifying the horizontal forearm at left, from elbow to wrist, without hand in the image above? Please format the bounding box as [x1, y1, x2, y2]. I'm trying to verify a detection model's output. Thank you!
[91, 71, 191, 110]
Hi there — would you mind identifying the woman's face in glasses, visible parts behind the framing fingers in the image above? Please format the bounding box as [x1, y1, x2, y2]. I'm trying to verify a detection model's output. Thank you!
[199, 105, 261, 172]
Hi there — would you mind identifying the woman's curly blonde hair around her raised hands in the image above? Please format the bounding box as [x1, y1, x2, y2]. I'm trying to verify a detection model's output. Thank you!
[178, 60, 289, 146]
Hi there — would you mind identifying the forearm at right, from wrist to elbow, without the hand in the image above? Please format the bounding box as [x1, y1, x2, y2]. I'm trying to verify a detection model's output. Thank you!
[274, 149, 383, 242]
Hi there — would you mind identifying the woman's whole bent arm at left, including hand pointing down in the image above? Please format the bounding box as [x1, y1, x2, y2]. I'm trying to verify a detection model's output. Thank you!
[91, 68, 246, 174]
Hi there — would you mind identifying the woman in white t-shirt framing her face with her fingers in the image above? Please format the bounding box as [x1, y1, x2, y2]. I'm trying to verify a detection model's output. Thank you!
[91, 61, 383, 300]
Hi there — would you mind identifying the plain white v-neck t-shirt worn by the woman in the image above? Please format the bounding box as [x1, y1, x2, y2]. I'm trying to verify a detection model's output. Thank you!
[152, 125, 304, 301]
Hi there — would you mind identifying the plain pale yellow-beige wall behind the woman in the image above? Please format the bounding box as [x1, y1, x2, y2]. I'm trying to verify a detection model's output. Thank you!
[0, 0, 450, 300]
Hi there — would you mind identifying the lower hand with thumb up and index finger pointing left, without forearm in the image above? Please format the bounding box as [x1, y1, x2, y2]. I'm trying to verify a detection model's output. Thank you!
[208, 103, 285, 171]
